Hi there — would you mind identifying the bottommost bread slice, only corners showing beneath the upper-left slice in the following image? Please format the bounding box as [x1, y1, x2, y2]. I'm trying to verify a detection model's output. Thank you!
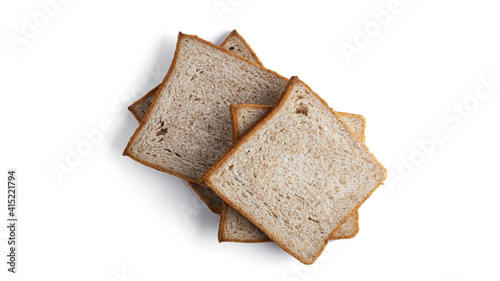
[128, 29, 262, 214]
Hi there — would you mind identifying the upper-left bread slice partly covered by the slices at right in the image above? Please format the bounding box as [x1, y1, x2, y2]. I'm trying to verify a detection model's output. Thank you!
[123, 33, 288, 185]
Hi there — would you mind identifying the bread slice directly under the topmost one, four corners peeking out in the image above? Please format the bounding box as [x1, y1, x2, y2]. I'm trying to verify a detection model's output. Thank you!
[218, 104, 366, 243]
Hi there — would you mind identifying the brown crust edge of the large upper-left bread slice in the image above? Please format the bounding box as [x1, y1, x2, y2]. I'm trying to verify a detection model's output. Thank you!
[123, 32, 287, 186]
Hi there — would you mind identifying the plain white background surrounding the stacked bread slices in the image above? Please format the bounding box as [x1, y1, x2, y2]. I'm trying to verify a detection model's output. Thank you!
[0, 0, 500, 281]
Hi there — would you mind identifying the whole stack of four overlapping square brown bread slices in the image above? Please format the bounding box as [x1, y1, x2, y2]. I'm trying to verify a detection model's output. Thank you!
[124, 31, 387, 264]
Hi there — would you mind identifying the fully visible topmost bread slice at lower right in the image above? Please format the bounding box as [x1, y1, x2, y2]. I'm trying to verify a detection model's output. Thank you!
[202, 77, 387, 264]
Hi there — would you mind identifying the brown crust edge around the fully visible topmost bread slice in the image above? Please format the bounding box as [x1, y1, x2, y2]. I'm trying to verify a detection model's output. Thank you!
[201, 76, 387, 264]
